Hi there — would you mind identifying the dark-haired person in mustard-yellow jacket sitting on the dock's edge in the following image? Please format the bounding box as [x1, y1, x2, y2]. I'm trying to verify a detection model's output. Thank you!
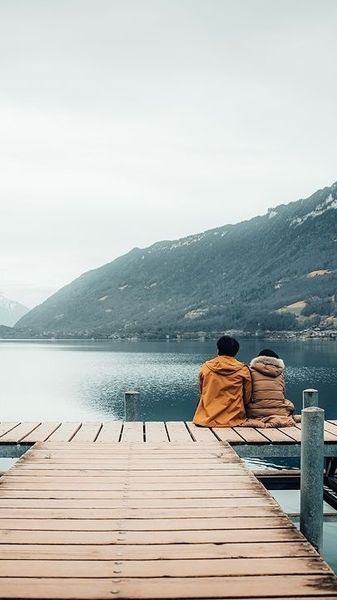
[193, 335, 252, 427]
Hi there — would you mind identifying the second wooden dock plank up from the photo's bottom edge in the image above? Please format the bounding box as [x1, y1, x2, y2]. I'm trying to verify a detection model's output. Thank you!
[0, 556, 329, 586]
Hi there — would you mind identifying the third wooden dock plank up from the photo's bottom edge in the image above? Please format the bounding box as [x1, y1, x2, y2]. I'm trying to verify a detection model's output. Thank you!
[0, 530, 317, 561]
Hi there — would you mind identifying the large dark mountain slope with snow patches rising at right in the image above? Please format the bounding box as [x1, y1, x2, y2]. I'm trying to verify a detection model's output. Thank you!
[17, 182, 337, 337]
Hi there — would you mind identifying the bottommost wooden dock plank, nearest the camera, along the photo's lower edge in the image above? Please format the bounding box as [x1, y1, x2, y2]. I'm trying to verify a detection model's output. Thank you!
[0, 573, 337, 600]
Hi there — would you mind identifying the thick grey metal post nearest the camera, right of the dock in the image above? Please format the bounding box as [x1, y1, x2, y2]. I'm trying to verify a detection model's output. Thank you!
[300, 406, 324, 552]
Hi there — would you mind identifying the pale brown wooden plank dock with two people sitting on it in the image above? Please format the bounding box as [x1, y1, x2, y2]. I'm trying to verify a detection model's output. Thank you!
[0, 422, 337, 600]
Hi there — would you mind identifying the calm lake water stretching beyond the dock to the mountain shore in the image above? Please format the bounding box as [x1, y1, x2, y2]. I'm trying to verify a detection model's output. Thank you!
[0, 340, 337, 421]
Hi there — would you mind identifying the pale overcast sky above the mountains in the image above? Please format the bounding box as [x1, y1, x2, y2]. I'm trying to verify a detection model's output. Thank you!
[0, 0, 337, 307]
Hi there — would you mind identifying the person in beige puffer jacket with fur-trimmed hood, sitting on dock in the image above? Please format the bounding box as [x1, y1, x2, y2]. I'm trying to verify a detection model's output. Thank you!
[246, 348, 298, 427]
